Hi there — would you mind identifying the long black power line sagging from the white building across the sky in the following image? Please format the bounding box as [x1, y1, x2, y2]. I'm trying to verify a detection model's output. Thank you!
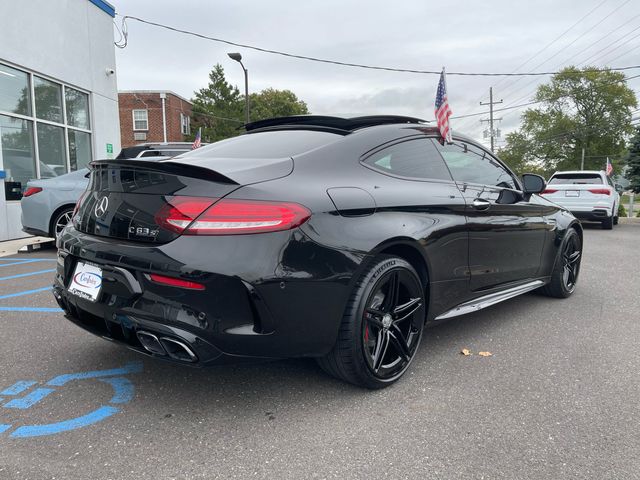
[117, 14, 640, 77]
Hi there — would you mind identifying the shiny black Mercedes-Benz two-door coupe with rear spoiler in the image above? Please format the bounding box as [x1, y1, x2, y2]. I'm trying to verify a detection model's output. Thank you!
[53, 116, 582, 388]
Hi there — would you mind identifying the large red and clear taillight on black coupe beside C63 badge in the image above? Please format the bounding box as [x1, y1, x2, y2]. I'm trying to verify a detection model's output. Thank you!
[184, 199, 311, 235]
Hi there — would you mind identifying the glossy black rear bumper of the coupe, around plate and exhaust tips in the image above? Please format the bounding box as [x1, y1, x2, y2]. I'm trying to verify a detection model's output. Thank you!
[53, 227, 358, 365]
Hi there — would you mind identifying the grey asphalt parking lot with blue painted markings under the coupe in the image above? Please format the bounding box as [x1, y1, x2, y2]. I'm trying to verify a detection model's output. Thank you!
[0, 224, 640, 480]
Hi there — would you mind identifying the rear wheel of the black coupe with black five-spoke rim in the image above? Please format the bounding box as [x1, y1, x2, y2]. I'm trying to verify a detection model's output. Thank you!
[318, 255, 426, 389]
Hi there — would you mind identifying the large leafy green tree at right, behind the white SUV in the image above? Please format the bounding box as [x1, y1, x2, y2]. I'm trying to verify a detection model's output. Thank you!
[500, 67, 637, 175]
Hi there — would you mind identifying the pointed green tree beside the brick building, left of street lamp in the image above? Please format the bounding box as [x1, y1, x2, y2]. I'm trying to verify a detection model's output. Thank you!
[191, 64, 244, 142]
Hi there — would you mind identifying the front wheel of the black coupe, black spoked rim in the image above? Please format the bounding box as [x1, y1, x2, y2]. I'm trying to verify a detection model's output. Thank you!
[540, 228, 582, 298]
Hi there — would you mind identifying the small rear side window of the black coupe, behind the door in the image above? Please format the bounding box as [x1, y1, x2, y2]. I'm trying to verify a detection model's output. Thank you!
[363, 138, 451, 181]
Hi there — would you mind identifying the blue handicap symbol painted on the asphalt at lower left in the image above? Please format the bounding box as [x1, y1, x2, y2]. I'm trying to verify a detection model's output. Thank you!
[0, 362, 142, 438]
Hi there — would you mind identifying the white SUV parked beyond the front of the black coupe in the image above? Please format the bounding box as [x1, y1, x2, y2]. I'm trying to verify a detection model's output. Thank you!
[542, 170, 620, 230]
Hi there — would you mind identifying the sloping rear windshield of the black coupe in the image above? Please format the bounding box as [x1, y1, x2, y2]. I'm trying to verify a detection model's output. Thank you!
[176, 130, 342, 159]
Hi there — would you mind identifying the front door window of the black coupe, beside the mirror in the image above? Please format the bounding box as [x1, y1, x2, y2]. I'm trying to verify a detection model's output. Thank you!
[438, 143, 518, 190]
